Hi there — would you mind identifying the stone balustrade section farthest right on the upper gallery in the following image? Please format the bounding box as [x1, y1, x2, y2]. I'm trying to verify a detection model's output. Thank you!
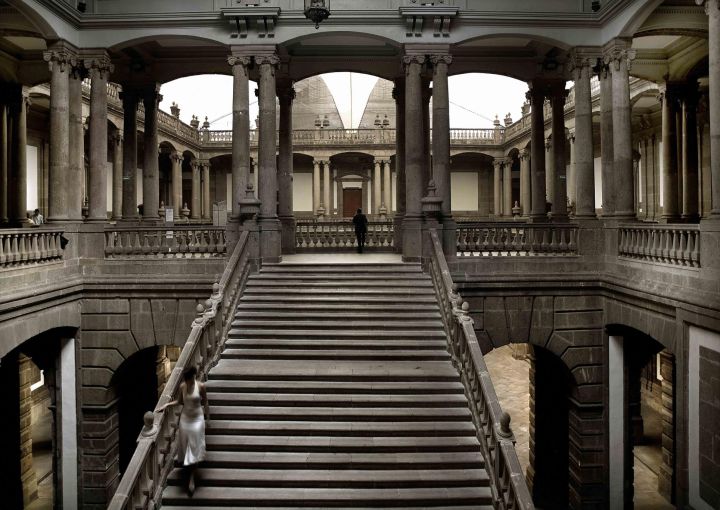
[618, 225, 700, 268]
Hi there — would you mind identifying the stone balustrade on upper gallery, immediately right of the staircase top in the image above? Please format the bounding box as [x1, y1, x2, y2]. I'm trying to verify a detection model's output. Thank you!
[457, 222, 578, 257]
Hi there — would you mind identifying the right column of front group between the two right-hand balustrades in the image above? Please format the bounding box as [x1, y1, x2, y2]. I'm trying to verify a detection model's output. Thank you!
[605, 40, 635, 219]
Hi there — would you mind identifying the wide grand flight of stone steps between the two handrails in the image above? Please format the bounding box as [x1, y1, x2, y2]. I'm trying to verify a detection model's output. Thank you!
[162, 264, 492, 509]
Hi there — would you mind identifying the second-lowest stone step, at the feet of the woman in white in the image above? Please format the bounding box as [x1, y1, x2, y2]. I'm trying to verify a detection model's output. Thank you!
[168, 467, 489, 488]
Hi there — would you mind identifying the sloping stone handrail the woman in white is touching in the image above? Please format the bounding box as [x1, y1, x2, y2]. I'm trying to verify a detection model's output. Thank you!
[108, 232, 252, 510]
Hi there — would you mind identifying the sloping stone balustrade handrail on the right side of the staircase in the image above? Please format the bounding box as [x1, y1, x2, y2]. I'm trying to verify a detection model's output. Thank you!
[427, 229, 535, 510]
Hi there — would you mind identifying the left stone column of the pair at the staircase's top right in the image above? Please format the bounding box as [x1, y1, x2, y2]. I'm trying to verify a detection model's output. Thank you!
[402, 55, 427, 261]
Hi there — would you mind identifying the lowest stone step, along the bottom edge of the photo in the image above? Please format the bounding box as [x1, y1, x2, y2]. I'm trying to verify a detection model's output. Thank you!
[163, 486, 492, 508]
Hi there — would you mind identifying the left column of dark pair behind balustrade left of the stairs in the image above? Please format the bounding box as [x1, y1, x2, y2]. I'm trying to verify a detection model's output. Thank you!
[120, 87, 138, 221]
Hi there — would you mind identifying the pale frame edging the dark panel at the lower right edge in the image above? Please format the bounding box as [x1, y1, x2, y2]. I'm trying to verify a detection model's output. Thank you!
[688, 326, 720, 510]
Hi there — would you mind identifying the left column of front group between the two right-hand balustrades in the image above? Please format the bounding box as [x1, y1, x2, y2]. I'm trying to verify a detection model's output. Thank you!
[569, 56, 595, 218]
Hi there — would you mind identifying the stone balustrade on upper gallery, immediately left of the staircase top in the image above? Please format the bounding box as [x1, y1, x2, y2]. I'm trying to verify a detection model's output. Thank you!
[105, 226, 227, 258]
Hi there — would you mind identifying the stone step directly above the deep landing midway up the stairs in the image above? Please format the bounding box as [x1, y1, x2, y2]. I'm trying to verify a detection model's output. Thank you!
[221, 348, 450, 361]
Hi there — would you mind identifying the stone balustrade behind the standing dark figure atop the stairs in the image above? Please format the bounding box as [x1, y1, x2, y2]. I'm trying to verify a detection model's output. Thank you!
[295, 220, 395, 251]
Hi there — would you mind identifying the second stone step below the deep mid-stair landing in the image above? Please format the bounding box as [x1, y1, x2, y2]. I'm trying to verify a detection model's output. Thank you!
[208, 389, 467, 408]
